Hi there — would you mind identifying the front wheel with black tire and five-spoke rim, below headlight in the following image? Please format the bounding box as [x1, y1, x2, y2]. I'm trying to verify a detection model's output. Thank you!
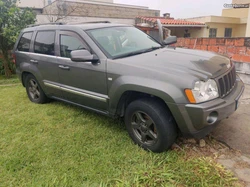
[125, 98, 177, 153]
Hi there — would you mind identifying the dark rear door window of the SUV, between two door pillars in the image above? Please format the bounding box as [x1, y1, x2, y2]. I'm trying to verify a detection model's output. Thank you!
[34, 31, 55, 55]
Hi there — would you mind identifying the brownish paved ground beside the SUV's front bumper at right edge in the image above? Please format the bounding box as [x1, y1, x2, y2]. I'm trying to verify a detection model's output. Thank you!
[212, 85, 250, 155]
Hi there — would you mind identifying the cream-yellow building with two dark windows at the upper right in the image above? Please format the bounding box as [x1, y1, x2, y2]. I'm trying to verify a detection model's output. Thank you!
[185, 0, 250, 37]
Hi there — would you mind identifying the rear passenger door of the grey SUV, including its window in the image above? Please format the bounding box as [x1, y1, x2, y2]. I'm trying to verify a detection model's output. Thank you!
[30, 30, 62, 98]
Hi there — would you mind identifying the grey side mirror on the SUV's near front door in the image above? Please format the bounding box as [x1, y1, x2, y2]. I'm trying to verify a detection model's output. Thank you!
[70, 49, 99, 62]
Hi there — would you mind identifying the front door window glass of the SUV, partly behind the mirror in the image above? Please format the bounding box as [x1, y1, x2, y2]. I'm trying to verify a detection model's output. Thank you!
[60, 35, 85, 58]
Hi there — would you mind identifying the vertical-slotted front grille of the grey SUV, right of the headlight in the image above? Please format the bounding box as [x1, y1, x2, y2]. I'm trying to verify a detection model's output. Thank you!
[217, 66, 236, 97]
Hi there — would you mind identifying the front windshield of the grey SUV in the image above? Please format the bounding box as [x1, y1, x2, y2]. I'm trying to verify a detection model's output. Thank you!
[87, 27, 161, 59]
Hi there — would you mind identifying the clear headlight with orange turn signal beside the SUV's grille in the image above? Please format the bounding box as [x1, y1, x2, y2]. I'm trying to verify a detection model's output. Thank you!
[185, 79, 219, 103]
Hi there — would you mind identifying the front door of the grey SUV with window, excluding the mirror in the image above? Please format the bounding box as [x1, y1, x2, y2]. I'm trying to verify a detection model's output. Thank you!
[58, 31, 108, 113]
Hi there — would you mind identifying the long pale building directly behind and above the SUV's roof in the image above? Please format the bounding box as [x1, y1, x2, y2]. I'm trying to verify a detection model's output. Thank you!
[18, 0, 160, 24]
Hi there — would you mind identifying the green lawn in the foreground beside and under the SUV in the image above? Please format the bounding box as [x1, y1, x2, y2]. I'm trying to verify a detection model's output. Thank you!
[0, 85, 242, 187]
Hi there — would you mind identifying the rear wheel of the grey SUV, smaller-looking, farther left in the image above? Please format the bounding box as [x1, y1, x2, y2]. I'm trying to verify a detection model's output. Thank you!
[25, 74, 49, 104]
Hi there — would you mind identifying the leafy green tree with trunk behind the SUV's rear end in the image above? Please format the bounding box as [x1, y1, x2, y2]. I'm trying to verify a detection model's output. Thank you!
[0, 0, 36, 77]
